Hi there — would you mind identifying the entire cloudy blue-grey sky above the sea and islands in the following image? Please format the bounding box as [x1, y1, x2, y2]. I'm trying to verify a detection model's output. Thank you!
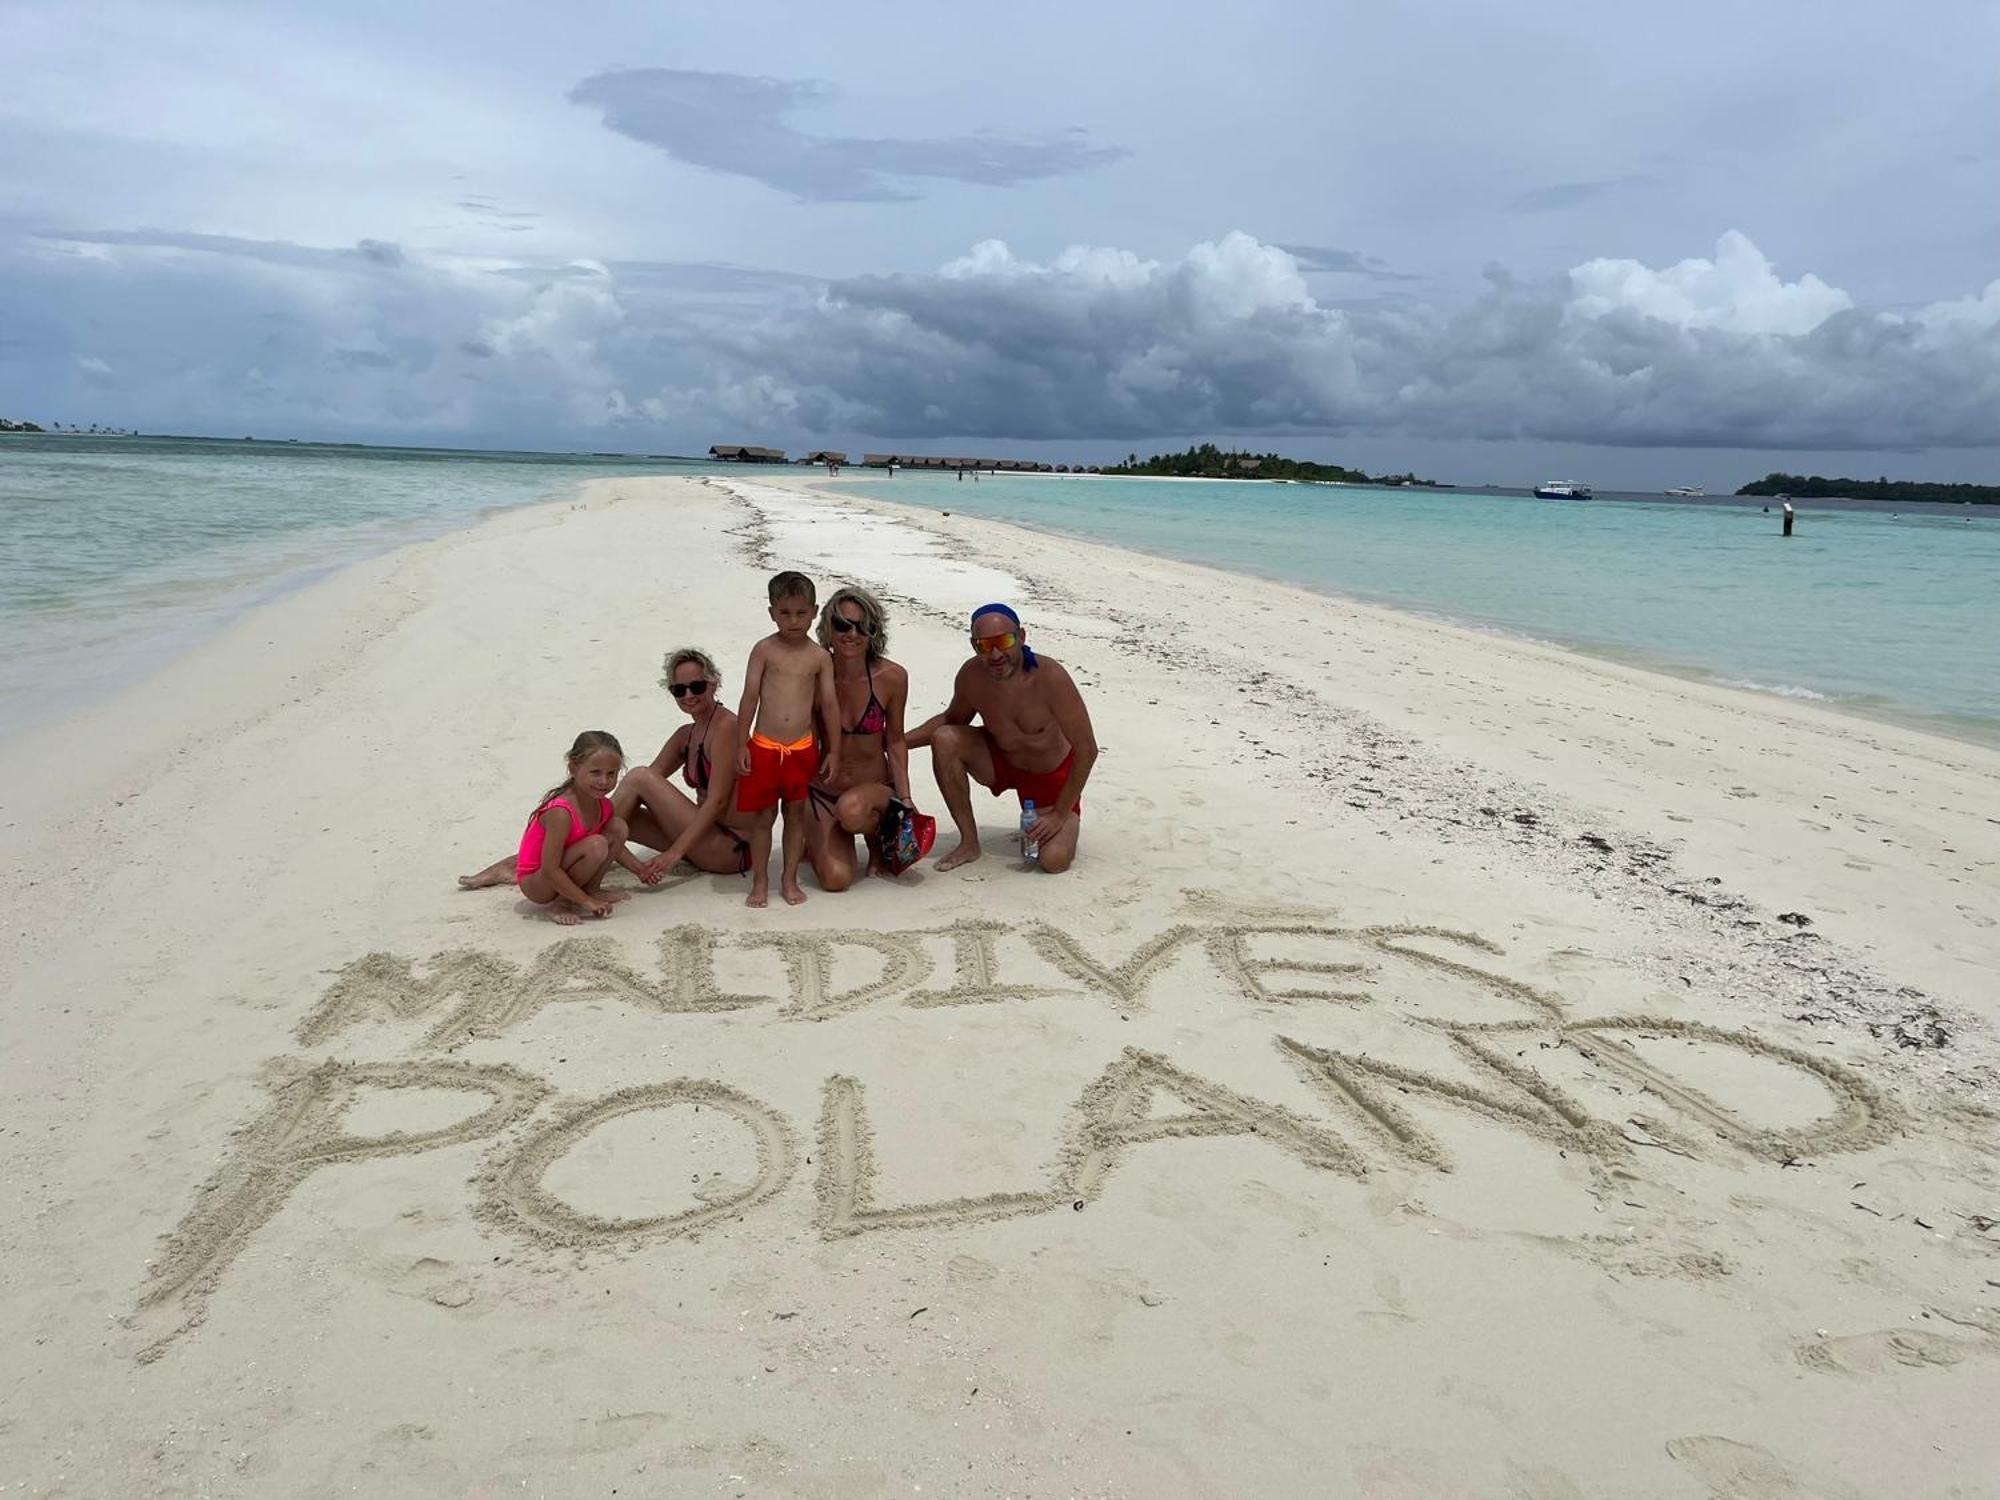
[0, 0, 2000, 488]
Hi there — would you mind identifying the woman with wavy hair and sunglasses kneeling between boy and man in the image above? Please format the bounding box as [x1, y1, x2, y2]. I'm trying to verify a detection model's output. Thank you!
[804, 588, 910, 890]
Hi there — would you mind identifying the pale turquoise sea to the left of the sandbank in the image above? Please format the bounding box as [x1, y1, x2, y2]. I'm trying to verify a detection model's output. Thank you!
[0, 434, 714, 734]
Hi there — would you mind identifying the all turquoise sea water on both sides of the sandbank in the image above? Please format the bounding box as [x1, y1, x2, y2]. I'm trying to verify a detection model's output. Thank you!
[0, 436, 2000, 744]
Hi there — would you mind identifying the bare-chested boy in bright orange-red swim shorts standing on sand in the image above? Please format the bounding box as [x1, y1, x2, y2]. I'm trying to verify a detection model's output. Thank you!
[736, 572, 840, 906]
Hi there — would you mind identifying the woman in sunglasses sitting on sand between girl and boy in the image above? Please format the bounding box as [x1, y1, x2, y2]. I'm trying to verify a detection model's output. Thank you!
[458, 646, 750, 890]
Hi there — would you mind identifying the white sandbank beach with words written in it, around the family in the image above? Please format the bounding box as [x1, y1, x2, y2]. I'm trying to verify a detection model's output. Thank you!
[0, 476, 2000, 1500]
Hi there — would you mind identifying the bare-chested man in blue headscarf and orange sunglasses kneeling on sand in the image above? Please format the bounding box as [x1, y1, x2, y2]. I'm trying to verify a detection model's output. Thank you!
[908, 604, 1098, 874]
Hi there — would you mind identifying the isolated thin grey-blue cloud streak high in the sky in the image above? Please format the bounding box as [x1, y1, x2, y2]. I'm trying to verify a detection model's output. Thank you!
[570, 68, 1126, 202]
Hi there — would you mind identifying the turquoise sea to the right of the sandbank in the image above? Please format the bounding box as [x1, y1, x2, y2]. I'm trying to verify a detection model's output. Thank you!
[840, 474, 2000, 744]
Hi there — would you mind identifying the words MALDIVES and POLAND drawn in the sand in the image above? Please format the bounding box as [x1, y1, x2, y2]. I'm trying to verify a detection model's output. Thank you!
[138, 896, 1898, 1358]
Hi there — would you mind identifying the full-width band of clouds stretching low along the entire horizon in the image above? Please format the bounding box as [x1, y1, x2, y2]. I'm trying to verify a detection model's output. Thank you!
[0, 232, 2000, 452]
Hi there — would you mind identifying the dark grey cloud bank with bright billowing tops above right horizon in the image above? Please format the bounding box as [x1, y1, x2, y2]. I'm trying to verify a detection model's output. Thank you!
[652, 236, 2000, 450]
